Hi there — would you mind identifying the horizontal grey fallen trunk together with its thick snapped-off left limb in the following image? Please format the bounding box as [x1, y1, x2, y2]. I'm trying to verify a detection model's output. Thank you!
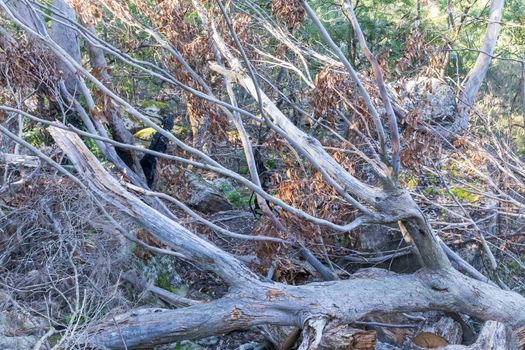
[49, 127, 525, 349]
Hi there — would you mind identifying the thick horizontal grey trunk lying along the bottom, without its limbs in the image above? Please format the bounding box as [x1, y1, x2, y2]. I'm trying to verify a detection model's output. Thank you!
[81, 270, 525, 349]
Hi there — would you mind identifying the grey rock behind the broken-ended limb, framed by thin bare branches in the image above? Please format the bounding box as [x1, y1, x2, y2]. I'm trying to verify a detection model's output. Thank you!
[186, 173, 233, 214]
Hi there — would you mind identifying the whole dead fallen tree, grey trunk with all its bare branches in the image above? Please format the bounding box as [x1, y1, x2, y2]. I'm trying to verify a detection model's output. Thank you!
[0, 0, 525, 349]
